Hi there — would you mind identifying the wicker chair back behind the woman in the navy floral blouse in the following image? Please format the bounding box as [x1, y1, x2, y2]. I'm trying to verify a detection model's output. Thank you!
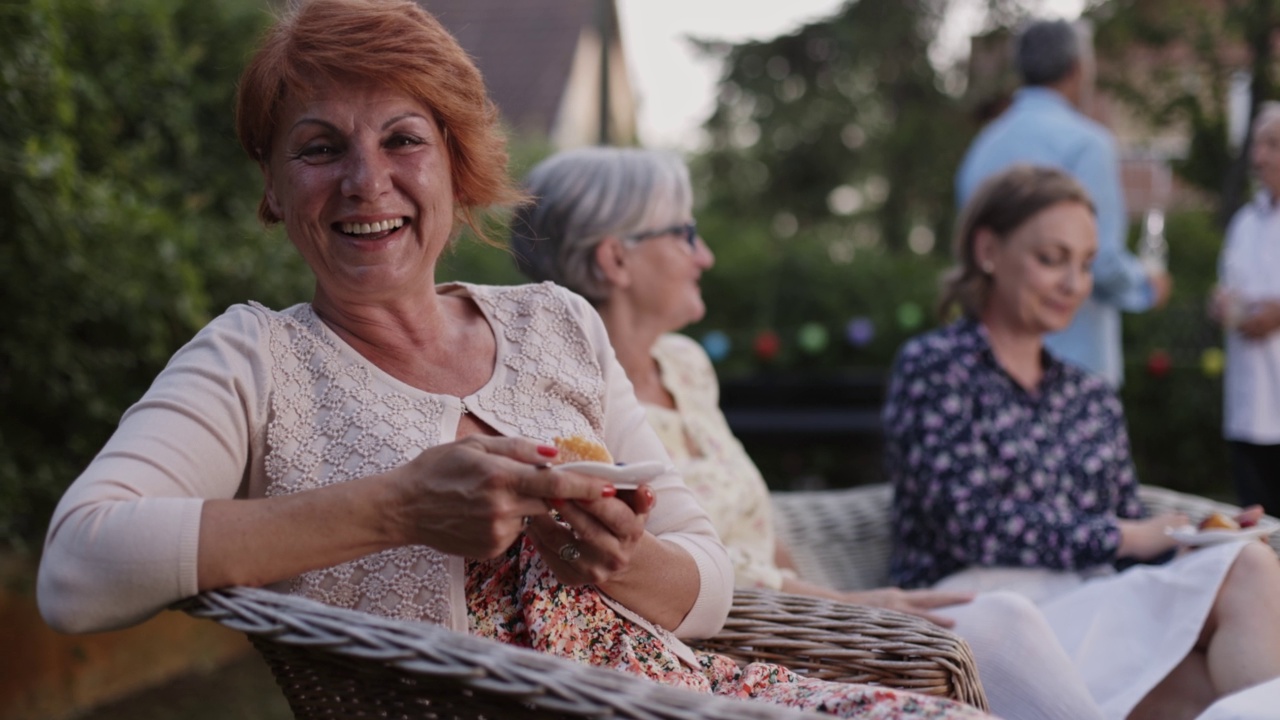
[773, 483, 1280, 591]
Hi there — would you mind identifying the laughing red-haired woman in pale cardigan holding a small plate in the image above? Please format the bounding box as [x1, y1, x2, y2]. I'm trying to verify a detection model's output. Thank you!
[37, 0, 984, 720]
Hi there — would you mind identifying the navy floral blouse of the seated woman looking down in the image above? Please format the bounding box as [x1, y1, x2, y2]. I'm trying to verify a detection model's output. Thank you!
[884, 319, 1142, 587]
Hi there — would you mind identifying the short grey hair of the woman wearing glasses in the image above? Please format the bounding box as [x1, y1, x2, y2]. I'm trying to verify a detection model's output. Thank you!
[511, 147, 692, 304]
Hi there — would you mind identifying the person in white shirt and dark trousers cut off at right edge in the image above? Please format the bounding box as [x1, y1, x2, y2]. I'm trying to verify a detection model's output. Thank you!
[1210, 101, 1280, 509]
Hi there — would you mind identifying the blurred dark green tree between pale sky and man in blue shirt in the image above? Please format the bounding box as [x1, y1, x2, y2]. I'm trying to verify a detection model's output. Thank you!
[695, 0, 968, 254]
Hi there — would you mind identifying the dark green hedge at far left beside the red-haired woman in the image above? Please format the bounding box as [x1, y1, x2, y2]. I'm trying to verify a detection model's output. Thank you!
[0, 0, 310, 546]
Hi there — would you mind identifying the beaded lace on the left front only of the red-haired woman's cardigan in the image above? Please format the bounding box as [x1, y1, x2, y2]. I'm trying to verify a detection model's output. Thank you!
[265, 305, 451, 625]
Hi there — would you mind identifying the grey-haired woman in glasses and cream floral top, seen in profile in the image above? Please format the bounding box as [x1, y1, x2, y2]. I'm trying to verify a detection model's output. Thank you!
[511, 147, 1101, 720]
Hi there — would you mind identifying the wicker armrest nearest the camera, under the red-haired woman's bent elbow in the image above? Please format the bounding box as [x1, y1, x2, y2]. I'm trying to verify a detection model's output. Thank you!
[177, 588, 815, 720]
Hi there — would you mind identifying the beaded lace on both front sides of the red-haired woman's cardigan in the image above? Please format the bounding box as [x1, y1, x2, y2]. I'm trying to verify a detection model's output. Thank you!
[254, 283, 604, 625]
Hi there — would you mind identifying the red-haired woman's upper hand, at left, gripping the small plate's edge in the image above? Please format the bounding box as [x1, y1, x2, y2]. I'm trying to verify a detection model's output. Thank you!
[388, 434, 611, 559]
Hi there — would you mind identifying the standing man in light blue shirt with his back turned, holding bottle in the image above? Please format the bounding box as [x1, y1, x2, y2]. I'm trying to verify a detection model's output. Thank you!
[956, 20, 1172, 387]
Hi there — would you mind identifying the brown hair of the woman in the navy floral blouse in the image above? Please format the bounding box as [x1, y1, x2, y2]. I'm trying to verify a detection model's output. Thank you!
[938, 164, 1097, 320]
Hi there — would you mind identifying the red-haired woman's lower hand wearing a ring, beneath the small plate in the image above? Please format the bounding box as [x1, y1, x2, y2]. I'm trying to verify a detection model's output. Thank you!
[529, 481, 654, 585]
